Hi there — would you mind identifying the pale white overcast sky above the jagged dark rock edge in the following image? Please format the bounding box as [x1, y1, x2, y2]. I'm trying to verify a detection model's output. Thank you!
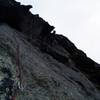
[17, 0, 100, 63]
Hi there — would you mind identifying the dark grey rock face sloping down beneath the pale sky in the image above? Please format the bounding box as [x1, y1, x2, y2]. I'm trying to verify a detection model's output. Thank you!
[0, 0, 100, 100]
